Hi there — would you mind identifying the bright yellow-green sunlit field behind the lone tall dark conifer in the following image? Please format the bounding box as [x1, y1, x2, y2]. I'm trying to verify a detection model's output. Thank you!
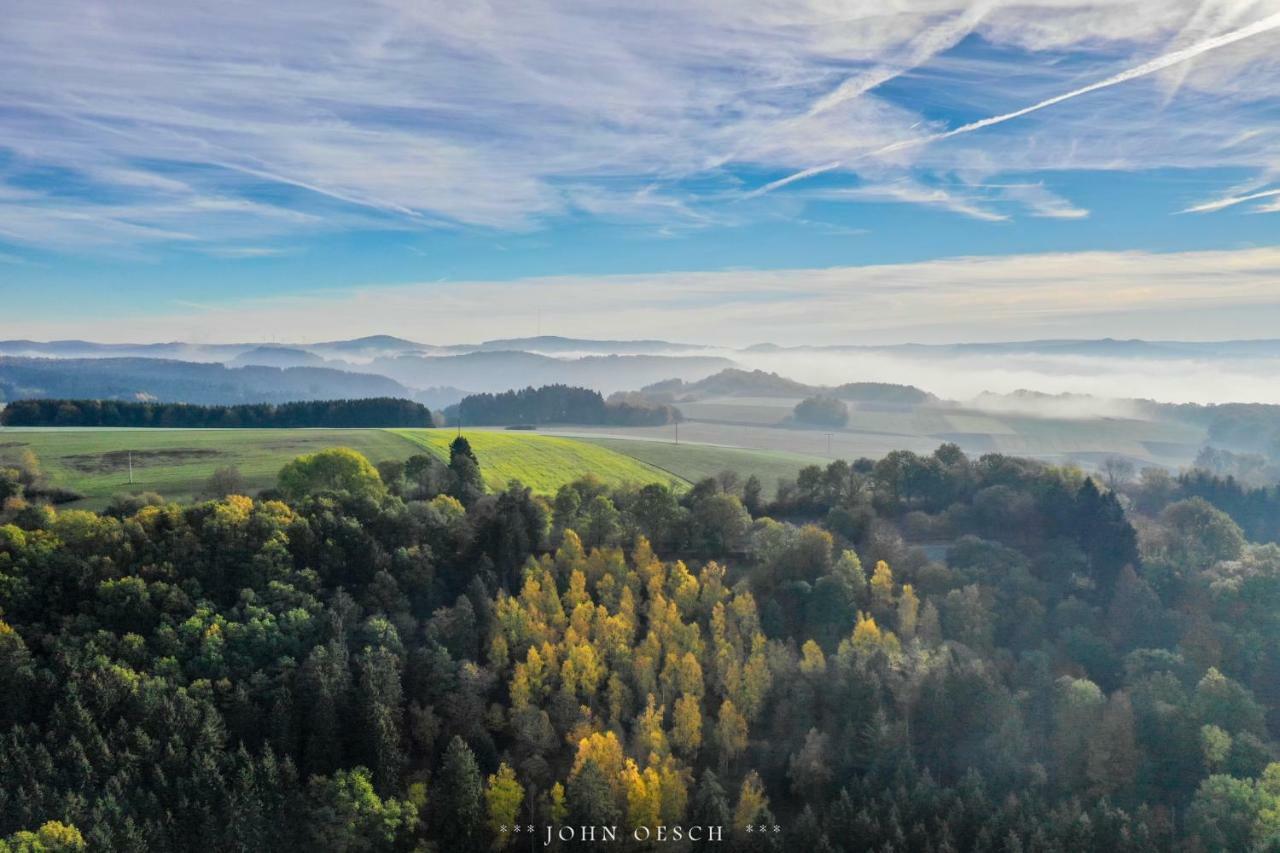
[388, 429, 687, 493]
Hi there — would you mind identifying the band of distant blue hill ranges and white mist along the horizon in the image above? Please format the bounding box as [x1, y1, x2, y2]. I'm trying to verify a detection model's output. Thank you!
[0, 334, 1280, 409]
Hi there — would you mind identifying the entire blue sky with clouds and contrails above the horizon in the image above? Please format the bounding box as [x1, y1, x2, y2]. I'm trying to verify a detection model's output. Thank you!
[0, 0, 1280, 346]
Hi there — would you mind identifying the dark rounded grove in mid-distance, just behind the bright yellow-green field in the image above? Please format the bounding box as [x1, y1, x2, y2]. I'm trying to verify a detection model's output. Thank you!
[444, 386, 680, 427]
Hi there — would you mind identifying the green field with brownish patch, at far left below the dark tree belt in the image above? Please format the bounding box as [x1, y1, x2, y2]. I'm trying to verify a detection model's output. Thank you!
[0, 428, 416, 508]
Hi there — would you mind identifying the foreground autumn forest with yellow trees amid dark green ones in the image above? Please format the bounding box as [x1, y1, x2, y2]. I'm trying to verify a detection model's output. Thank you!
[0, 438, 1280, 853]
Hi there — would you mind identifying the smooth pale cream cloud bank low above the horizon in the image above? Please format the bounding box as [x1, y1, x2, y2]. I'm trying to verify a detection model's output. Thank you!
[15, 247, 1280, 345]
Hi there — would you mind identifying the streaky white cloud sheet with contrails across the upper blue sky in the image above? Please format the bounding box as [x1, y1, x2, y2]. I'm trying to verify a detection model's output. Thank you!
[0, 0, 1280, 248]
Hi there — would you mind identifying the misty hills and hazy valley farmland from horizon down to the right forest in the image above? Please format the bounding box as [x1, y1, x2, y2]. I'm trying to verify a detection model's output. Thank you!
[12, 336, 1280, 473]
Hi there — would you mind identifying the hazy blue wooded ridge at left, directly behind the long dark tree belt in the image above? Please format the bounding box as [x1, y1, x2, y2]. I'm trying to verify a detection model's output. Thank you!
[0, 356, 411, 405]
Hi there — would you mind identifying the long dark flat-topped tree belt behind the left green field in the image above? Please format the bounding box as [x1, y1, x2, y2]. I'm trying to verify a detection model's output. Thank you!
[0, 397, 431, 429]
